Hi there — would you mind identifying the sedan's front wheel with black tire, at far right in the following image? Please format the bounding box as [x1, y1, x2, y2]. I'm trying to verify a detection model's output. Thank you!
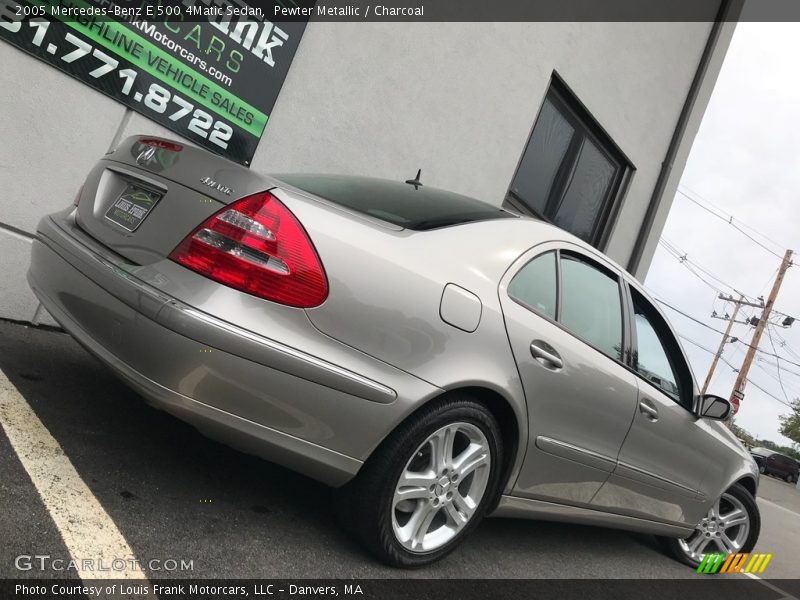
[662, 483, 761, 568]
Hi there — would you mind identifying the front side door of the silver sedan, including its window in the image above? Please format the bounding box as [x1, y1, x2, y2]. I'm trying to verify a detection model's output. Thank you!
[592, 289, 708, 523]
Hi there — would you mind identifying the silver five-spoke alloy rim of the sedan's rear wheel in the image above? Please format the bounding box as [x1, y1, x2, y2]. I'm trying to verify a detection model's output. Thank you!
[391, 423, 492, 554]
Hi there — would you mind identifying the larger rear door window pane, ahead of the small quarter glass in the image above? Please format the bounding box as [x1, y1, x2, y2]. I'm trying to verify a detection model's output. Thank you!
[559, 253, 623, 360]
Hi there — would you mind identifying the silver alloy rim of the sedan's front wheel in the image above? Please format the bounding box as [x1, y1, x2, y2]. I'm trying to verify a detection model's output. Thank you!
[679, 493, 750, 563]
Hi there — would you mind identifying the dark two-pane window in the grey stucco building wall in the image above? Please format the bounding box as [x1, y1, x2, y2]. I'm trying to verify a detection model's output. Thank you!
[505, 79, 631, 247]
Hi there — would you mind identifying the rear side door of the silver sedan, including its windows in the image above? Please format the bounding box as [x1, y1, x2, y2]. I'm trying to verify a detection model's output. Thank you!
[499, 243, 637, 505]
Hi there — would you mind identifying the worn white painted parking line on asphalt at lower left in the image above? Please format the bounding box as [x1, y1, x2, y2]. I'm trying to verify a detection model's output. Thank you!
[0, 371, 146, 579]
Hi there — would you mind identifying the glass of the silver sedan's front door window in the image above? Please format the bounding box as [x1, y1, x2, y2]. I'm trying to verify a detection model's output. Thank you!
[633, 294, 681, 402]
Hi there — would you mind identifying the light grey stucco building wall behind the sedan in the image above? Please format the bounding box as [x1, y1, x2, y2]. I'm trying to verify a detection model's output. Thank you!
[0, 23, 729, 321]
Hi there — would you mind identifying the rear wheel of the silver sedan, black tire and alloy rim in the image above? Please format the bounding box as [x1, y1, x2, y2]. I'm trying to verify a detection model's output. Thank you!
[340, 394, 503, 568]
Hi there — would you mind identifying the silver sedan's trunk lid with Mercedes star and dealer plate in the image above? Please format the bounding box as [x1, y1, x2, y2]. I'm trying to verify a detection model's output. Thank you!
[77, 136, 271, 264]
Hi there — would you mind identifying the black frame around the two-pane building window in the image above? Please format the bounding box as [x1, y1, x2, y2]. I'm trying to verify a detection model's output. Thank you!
[503, 70, 636, 251]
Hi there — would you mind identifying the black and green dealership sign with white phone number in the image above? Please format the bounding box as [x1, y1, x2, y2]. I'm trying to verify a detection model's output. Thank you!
[0, 0, 306, 164]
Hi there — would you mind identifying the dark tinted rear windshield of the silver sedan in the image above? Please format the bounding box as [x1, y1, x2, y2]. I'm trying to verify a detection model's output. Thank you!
[275, 174, 516, 231]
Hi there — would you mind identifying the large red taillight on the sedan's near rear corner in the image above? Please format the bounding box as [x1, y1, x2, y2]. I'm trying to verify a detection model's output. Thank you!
[169, 192, 328, 308]
